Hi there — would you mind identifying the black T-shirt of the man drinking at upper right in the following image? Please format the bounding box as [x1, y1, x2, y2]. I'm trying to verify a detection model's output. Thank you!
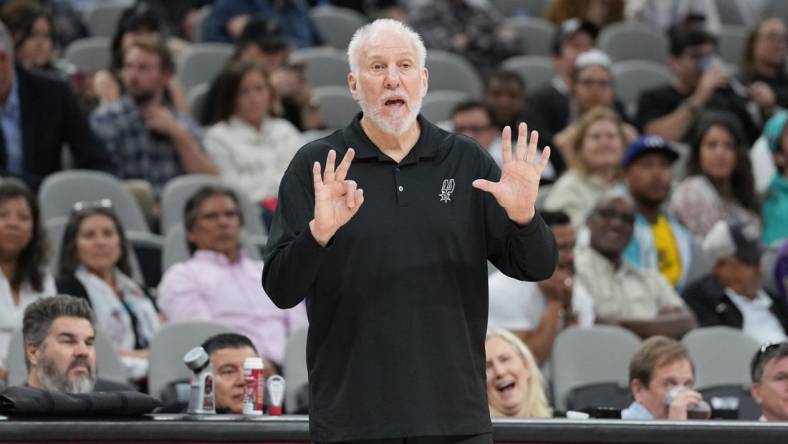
[635, 85, 760, 146]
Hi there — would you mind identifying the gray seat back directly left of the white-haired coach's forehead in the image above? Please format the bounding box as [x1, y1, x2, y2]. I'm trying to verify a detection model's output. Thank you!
[289, 48, 350, 88]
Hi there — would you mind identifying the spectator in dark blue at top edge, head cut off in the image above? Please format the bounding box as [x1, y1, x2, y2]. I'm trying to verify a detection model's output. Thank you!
[205, 0, 323, 48]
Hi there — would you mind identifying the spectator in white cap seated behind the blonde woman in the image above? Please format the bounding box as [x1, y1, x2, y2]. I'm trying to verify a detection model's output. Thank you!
[548, 49, 637, 158]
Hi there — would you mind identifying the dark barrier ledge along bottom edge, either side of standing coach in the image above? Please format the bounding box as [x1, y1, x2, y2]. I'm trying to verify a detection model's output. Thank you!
[0, 415, 788, 444]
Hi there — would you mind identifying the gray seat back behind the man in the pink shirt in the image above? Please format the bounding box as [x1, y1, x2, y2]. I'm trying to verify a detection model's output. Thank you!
[160, 174, 266, 236]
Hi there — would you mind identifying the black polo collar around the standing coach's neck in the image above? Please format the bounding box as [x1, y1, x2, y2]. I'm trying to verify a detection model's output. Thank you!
[342, 112, 440, 165]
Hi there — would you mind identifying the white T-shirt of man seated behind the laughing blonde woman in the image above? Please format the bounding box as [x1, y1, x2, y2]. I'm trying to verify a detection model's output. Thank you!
[488, 270, 594, 330]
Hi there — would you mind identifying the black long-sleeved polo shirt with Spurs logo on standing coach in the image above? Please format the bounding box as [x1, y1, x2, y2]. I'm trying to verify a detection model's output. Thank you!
[263, 114, 557, 441]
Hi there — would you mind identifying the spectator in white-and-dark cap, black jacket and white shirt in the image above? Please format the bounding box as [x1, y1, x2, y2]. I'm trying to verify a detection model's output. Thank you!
[682, 221, 788, 343]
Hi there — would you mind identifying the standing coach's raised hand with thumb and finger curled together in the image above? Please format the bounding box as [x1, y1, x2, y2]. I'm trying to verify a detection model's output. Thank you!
[309, 148, 364, 247]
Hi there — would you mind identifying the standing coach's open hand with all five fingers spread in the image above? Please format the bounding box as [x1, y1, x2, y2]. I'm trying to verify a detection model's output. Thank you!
[473, 123, 550, 225]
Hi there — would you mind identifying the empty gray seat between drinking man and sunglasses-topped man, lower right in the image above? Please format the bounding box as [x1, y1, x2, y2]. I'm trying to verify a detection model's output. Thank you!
[681, 327, 760, 389]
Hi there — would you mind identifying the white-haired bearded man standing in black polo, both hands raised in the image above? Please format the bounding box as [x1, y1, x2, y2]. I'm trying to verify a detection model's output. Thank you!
[263, 19, 557, 443]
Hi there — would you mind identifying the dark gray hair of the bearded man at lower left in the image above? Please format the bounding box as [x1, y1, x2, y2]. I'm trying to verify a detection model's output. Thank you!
[22, 295, 96, 370]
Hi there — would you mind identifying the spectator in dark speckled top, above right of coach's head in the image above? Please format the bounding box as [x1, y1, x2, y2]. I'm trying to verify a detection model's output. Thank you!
[408, 0, 523, 75]
